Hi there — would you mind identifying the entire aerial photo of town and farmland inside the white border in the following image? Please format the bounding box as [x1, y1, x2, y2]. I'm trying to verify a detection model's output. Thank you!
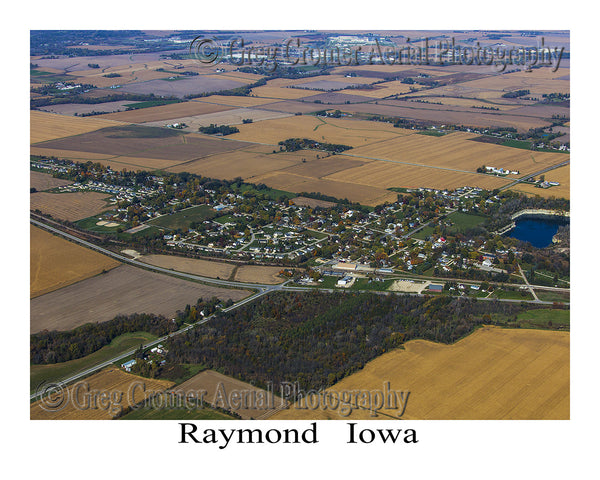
[29, 30, 571, 424]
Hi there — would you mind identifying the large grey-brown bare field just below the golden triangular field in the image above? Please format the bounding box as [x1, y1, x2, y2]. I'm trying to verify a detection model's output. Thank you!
[31, 265, 250, 333]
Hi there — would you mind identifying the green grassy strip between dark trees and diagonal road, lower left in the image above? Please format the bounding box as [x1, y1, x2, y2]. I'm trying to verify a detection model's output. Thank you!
[29, 332, 157, 392]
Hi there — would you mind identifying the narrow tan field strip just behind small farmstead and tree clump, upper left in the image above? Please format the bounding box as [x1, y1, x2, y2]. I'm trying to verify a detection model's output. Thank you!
[96, 102, 234, 123]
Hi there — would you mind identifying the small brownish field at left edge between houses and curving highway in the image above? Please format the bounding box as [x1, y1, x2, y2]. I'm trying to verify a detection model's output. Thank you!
[29, 192, 113, 222]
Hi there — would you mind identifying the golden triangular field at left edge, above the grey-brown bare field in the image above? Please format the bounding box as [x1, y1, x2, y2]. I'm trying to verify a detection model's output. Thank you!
[29, 226, 120, 298]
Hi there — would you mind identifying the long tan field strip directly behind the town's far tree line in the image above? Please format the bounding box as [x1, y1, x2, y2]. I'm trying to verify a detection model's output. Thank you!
[252, 172, 397, 206]
